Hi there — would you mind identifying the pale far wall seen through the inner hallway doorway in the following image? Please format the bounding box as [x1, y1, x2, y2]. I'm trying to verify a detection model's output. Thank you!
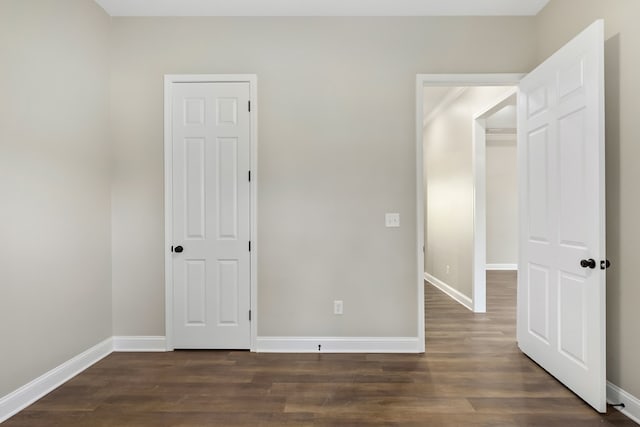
[486, 139, 518, 265]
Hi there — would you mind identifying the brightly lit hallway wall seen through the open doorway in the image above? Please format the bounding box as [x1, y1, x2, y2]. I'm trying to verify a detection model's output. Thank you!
[424, 87, 512, 298]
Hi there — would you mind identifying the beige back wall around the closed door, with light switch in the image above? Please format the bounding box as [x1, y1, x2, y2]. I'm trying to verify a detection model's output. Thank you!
[111, 18, 535, 337]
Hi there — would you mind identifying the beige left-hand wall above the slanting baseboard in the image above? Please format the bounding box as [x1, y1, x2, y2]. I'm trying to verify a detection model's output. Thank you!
[0, 0, 111, 397]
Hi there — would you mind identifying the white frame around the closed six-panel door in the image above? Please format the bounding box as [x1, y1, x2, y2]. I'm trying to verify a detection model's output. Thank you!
[164, 74, 259, 351]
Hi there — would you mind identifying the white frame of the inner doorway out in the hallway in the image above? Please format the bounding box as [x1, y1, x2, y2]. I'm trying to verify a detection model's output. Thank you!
[471, 87, 520, 313]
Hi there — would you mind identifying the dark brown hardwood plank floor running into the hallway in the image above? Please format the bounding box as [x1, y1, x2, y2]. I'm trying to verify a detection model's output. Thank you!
[6, 272, 636, 427]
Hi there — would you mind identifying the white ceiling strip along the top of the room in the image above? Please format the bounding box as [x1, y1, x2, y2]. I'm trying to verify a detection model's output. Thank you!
[95, 0, 549, 16]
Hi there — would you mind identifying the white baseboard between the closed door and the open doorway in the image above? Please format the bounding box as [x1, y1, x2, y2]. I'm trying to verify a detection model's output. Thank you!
[256, 337, 420, 353]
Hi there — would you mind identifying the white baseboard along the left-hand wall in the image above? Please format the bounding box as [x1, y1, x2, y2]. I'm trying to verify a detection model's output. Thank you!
[0, 338, 113, 423]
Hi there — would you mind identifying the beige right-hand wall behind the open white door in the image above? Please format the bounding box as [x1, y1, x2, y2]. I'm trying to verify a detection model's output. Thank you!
[537, 0, 640, 402]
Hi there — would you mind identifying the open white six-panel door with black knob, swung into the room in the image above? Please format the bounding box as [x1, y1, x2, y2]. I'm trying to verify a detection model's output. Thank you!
[517, 20, 606, 412]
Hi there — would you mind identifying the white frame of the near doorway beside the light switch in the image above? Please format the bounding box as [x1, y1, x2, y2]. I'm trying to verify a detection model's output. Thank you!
[416, 73, 526, 336]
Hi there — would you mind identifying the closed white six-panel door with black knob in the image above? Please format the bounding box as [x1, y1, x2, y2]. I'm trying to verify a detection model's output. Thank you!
[171, 82, 251, 349]
